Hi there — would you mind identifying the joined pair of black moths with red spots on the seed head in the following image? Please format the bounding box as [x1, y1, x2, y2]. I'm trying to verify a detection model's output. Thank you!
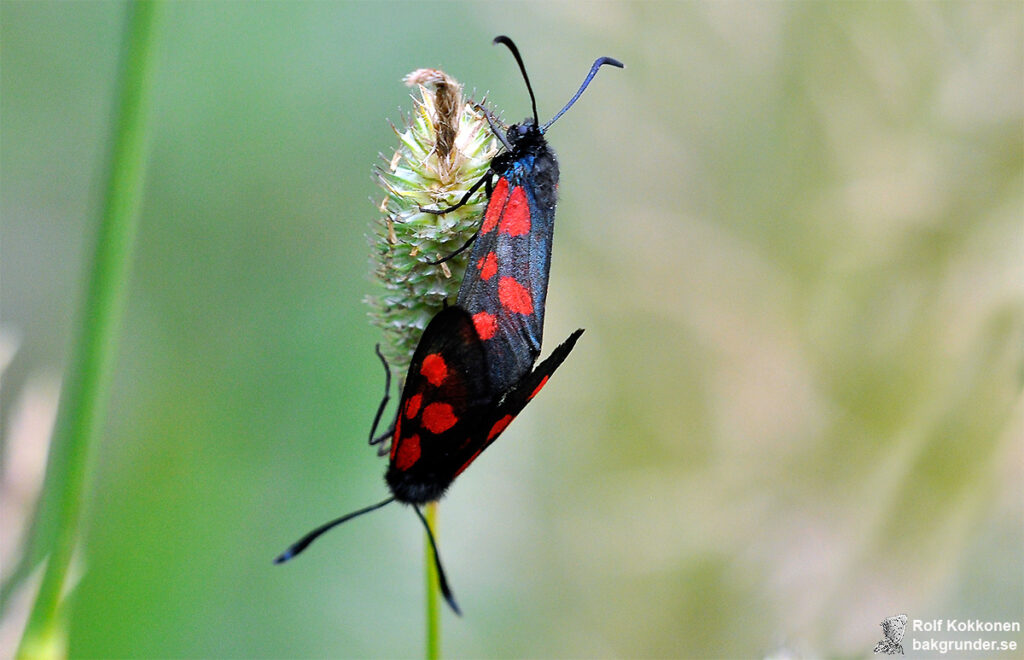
[274, 36, 623, 614]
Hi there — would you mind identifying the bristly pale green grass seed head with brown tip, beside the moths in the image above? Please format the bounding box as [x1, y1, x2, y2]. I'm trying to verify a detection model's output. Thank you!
[367, 69, 499, 372]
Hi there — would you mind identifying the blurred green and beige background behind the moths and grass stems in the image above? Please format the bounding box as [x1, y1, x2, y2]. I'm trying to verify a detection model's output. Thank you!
[0, 1, 1024, 657]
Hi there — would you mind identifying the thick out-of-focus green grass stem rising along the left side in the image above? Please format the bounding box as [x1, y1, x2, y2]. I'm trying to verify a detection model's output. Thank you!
[17, 0, 158, 658]
